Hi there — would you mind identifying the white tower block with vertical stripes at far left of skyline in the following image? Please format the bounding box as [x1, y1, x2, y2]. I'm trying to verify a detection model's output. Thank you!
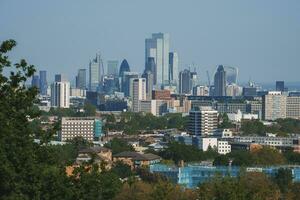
[51, 81, 70, 108]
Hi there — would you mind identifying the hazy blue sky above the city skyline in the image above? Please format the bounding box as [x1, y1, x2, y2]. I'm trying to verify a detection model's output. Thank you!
[0, 0, 300, 82]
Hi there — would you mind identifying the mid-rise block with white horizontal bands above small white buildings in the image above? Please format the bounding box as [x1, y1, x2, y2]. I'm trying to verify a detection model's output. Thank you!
[188, 106, 218, 136]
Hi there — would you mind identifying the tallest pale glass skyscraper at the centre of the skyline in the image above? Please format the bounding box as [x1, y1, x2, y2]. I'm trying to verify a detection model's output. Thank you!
[145, 33, 170, 86]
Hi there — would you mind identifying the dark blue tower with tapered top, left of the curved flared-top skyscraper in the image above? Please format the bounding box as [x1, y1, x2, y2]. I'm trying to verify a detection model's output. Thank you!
[214, 65, 226, 96]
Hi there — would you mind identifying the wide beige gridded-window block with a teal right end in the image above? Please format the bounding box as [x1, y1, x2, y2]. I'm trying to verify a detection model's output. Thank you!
[60, 117, 102, 141]
